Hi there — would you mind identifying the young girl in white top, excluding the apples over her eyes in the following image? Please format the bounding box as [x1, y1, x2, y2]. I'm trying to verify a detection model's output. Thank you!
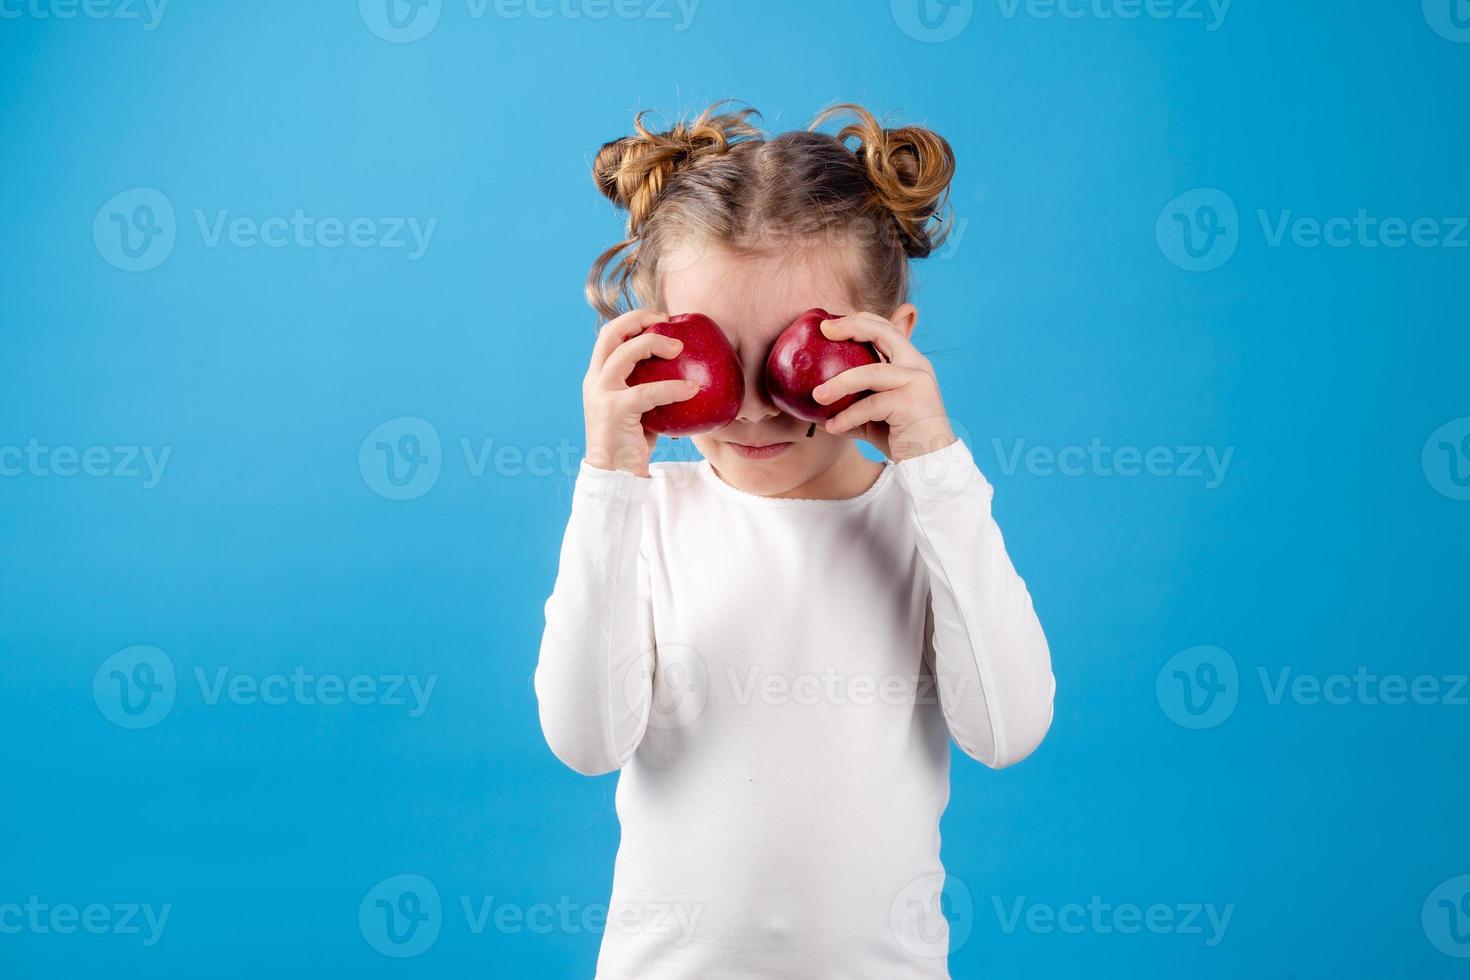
[535, 106, 1054, 980]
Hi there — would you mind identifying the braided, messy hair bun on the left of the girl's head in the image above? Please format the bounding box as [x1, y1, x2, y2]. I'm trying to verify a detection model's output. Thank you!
[592, 103, 761, 234]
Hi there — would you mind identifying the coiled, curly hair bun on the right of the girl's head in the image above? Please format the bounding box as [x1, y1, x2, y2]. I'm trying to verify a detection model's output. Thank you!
[811, 103, 954, 259]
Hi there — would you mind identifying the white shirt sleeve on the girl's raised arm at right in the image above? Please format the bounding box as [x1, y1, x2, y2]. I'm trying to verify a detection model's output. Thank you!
[897, 439, 1055, 768]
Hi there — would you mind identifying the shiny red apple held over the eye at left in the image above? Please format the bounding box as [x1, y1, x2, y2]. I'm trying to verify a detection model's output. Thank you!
[628, 313, 745, 436]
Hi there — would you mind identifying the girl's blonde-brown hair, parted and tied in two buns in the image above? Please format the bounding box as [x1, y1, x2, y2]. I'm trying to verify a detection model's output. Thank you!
[587, 103, 954, 319]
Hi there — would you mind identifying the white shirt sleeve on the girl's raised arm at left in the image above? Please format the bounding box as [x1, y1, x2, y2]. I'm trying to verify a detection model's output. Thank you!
[534, 460, 654, 776]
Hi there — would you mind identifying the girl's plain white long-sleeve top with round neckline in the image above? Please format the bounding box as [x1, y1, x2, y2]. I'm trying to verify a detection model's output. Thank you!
[535, 442, 1054, 980]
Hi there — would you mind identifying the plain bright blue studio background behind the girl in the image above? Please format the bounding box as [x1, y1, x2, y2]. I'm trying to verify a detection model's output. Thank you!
[0, 0, 1470, 979]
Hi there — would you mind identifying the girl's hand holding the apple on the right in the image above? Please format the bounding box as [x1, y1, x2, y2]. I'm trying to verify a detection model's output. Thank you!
[811, 313, 956, 463]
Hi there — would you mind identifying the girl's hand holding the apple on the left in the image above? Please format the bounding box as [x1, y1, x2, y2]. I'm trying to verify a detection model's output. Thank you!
[582, 310, 700, 476]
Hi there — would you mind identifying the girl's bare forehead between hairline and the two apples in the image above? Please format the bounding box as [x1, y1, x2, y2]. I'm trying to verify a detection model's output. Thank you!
[659, 248, 856, 341]
